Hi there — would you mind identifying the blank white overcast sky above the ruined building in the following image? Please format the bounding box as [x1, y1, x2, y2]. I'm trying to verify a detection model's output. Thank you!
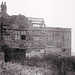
[0, 0, 75, 53]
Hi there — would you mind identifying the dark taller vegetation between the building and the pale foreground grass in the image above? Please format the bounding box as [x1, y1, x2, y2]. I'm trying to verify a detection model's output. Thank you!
[19, 54, 75, 75]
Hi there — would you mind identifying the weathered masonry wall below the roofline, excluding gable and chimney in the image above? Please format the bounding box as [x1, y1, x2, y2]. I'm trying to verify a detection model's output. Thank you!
[2, 27, 71, 56]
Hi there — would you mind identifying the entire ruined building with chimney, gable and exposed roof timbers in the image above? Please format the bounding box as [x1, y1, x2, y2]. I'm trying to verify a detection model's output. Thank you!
[0, 2, 71, 59]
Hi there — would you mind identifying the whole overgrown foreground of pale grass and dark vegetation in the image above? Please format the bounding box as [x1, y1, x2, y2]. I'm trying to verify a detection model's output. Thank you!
[0, 54, 75, 75]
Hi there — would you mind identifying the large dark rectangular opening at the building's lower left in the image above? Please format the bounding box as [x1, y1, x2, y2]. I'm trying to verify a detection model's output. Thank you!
[5, 49, 26, 62]
